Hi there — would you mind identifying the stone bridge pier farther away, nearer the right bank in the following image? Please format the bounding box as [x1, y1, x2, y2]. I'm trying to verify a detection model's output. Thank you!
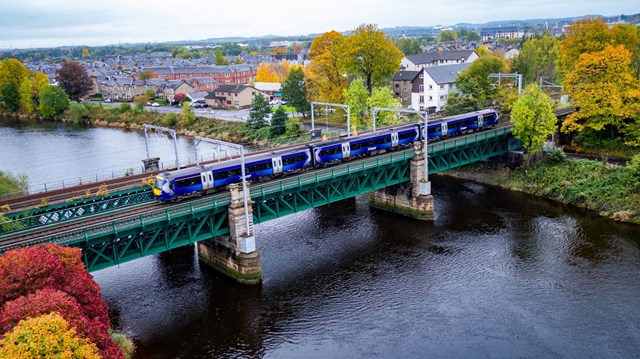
[369, 142, 434, 220]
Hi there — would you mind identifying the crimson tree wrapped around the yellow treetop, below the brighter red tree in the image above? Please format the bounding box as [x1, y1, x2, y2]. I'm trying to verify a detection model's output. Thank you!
[0, 288, 123, 358]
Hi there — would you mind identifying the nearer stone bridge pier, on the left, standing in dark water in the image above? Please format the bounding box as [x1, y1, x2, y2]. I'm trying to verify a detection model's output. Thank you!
[198, 183, 262, 284]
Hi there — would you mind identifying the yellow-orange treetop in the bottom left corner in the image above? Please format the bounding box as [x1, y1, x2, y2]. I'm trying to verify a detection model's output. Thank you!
[0, 313, 100, 359]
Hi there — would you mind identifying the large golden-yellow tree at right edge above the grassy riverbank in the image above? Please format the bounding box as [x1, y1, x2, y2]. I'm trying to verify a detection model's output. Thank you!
[562, 45, 640, 143]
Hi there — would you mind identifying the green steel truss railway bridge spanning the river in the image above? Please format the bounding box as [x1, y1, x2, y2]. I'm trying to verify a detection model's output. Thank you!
[0, 126, 522, 271]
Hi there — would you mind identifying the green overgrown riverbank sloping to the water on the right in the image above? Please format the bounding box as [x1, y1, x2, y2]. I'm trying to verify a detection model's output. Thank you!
[445, 155, 640, 224]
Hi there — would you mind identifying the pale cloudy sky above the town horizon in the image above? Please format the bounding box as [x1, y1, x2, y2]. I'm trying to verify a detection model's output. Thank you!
[0, 0, 640, 49]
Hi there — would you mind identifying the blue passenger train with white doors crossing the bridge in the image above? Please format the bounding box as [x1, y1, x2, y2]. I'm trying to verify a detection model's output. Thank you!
[153, 109, 498, 202]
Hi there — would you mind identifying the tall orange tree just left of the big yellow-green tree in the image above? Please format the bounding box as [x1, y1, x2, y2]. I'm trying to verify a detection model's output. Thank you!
[306, 31, 348, 103]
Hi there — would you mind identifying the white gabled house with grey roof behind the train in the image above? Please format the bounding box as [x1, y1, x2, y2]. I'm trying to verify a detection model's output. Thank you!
[411, 63, 469, 113]
